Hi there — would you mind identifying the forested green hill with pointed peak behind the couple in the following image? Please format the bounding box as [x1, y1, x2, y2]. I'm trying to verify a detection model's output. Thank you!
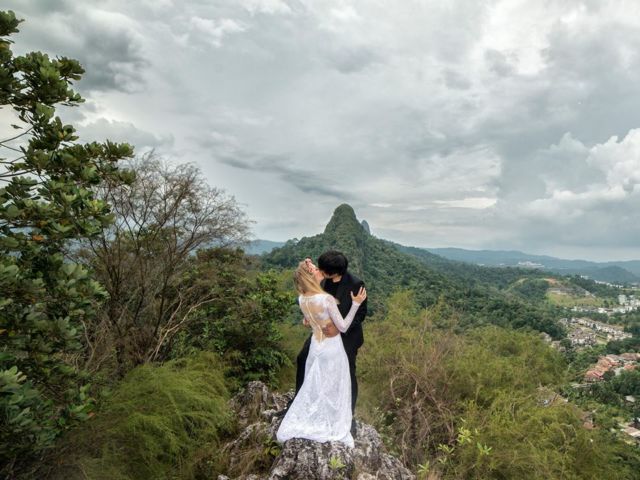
[262, 204, 561, 337]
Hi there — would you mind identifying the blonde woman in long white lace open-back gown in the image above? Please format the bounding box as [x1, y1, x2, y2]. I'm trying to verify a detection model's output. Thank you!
[276, 259, 367, 447]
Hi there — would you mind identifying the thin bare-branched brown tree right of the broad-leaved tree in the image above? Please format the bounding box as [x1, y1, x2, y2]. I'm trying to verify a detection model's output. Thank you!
[79, 154, 248, 373]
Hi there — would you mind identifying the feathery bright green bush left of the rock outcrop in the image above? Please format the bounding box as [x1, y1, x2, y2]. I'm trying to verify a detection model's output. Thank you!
[47, 353, 233, 480]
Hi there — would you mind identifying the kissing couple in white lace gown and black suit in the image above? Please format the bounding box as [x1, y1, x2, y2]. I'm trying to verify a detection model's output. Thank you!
[276, 251, 367, 447]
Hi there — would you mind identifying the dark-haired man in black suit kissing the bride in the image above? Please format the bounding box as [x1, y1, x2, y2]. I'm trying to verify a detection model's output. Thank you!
[296, 250, 367, 435]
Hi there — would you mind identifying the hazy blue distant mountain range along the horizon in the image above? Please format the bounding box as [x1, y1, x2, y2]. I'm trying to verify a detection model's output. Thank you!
[250, 236, 640, 284]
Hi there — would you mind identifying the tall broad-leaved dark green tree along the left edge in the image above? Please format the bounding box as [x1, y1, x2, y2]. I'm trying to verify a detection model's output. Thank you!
[0, 11, 132, 473]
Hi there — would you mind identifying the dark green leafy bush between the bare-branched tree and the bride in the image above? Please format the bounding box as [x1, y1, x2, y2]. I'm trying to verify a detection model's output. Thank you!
[173, 249, 295, 386]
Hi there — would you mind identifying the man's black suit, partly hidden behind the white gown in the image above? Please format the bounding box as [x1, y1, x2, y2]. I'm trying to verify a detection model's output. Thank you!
[296, 272, 367, 412]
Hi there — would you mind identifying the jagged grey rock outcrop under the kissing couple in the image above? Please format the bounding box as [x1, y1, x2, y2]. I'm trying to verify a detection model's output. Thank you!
[218, 382, 415, 480]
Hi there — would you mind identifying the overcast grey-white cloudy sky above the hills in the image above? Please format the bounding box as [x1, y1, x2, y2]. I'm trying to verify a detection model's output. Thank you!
[3, 0, 640, 260]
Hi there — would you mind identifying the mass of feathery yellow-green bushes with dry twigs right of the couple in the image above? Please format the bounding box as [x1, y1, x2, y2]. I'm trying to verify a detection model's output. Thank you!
[359, 292, 640, 479]
